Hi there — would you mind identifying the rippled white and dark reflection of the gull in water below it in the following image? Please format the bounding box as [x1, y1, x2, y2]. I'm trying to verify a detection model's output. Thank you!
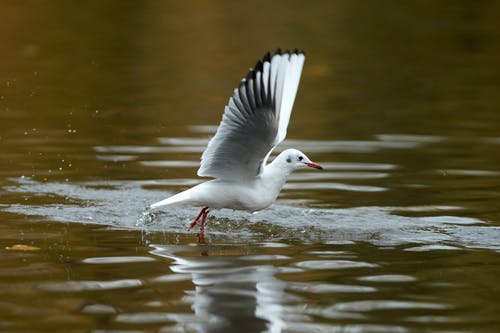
[151, 245, 292, 332]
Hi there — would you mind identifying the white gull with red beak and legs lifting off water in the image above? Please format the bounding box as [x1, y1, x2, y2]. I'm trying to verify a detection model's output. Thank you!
[151, 49, 322, 232]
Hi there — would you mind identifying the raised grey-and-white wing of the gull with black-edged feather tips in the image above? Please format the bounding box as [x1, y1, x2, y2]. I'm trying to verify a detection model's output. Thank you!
[198, 49, 305, 180]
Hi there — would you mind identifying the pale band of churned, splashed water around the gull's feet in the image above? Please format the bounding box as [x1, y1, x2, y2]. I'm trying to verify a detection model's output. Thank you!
[0, 177, 500, 251]
